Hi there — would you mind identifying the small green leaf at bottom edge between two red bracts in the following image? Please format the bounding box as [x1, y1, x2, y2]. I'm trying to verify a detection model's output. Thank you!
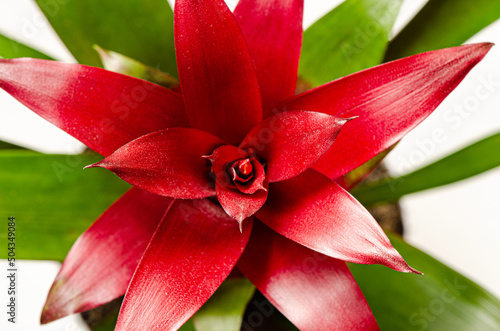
[192, 278, 255, 331]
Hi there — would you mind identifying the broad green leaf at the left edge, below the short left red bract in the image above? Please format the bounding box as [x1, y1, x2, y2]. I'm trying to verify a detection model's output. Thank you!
[0, 150, 129, 261]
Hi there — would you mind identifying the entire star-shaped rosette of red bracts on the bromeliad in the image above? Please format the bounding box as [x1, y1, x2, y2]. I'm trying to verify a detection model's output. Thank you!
[0, 0, 491, 331]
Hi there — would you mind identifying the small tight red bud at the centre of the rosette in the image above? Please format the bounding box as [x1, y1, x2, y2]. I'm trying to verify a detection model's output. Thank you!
[206, 145, 267, 194]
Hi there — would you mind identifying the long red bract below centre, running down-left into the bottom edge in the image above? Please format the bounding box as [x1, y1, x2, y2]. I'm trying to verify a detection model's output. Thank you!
[115, 199, 252, 331]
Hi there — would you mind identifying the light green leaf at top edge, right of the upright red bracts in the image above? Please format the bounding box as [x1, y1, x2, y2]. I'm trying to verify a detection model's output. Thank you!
[299, 0, 403, 86]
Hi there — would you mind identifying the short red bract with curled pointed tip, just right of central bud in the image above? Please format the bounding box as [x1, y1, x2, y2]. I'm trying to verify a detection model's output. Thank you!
[240, 111, 354, 182]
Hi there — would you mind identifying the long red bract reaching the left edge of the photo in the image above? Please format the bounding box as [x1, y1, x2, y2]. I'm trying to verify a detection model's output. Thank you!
[0, 59, 189, 156]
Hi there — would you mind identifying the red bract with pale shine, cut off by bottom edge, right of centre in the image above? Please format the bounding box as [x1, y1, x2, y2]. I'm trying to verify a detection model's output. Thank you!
[238, 222, 379, 331]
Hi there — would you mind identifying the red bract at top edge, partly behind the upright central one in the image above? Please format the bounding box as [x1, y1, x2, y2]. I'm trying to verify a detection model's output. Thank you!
[234, 0, 304, 118]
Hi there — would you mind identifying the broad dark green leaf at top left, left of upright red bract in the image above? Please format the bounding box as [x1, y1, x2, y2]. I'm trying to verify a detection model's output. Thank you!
[36, 0, 177, 76]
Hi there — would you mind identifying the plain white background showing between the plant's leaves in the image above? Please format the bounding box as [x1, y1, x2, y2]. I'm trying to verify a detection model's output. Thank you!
[0, 0, 500, 331]
